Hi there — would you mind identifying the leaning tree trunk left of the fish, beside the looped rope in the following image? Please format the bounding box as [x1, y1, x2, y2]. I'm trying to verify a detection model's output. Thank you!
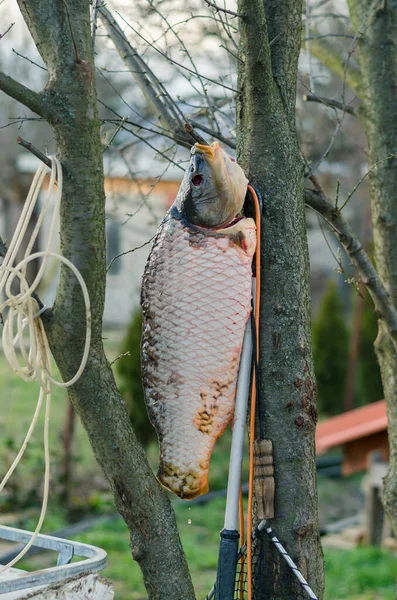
[11, 0, 195, 600]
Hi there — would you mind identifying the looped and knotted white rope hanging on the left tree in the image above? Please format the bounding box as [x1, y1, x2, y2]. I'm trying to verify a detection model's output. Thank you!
[0, 157, 91, 574]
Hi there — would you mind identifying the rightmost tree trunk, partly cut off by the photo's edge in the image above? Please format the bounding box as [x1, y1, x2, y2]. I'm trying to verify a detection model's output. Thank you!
[349, 0, 397, 532]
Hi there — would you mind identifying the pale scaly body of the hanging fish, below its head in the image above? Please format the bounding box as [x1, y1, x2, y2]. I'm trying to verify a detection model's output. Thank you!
[142, 216, 255, 498]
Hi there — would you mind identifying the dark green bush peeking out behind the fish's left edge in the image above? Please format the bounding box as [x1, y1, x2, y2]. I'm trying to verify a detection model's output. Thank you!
[116, 308, 156, 447]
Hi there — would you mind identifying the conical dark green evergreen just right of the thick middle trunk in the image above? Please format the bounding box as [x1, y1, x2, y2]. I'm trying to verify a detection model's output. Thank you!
[313, 280, 349, 416]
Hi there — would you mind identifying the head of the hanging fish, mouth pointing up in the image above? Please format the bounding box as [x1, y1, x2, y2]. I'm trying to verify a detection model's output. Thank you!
[177, 142, 248, 228]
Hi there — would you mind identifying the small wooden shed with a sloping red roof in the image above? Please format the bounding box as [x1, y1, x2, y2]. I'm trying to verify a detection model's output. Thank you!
[316, 400, 389, 475]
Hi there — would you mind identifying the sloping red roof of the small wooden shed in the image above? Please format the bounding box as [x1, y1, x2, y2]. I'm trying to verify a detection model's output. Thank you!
[316, 400, 387, 455]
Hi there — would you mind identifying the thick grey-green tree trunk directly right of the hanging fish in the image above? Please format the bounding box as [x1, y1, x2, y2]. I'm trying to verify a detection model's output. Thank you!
[237, 0, 324, 600]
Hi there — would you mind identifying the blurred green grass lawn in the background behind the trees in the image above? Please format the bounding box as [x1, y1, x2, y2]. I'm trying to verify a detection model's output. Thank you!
[0, 338, 397, 600]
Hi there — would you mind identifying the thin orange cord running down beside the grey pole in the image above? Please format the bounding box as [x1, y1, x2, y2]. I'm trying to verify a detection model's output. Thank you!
[247, 185, 261, 600]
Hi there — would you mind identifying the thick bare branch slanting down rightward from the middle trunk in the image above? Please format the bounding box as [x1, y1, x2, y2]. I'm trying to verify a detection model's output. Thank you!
[304, 175, 397, 349]
